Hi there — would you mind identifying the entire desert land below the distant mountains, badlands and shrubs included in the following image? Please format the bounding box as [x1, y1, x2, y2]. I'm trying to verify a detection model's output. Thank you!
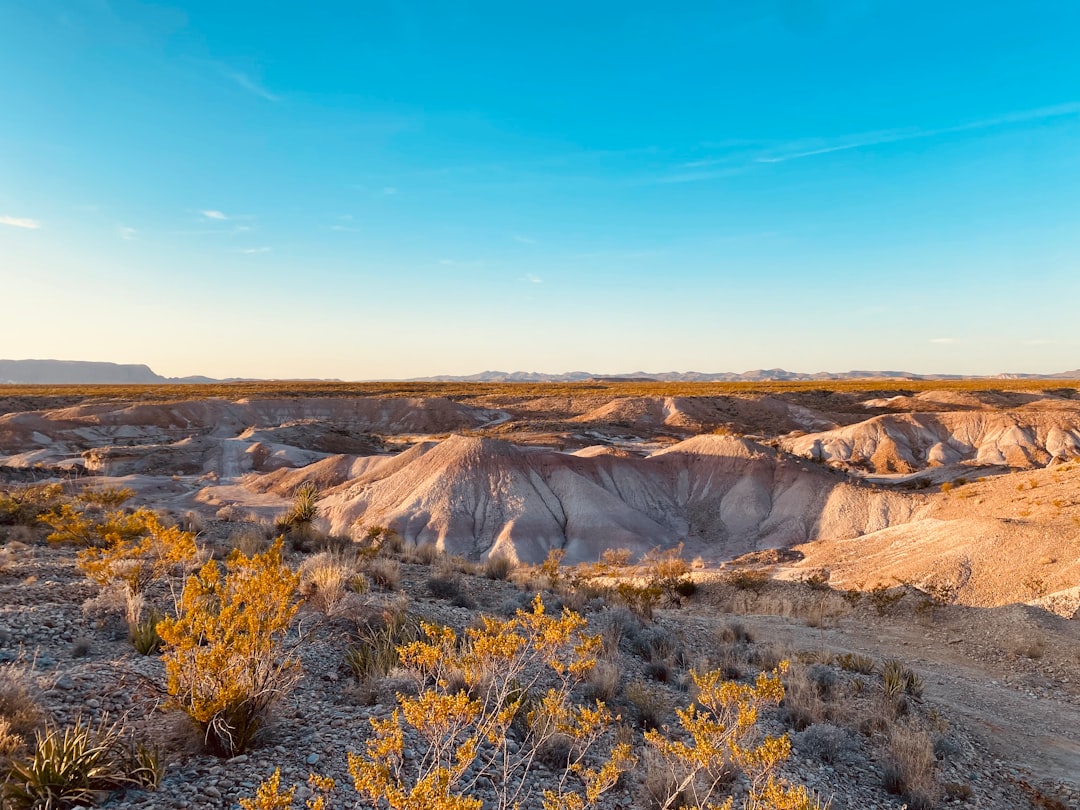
[0, 382, 1080, 810]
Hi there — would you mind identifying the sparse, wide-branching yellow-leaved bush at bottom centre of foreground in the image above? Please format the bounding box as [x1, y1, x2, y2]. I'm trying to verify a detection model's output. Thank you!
[349, 597, 633, 810]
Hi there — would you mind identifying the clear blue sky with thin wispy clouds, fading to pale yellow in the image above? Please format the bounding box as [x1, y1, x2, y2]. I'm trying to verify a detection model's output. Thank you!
[0, 0, 1080, 379]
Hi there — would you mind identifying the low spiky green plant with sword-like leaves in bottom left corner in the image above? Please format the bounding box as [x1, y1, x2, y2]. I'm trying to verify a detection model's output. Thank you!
[3, 718, 162, 810]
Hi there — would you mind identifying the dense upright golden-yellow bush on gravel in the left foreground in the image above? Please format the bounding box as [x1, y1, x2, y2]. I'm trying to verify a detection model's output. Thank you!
[158, 539, 299, 756]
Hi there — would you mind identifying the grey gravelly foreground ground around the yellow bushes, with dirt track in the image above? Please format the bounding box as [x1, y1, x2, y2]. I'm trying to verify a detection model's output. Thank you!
[0, 525, 1080, 810]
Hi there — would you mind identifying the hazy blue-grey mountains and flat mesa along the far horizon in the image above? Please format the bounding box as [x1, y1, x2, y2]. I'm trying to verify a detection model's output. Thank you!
[0, 360, 1080, 386]
